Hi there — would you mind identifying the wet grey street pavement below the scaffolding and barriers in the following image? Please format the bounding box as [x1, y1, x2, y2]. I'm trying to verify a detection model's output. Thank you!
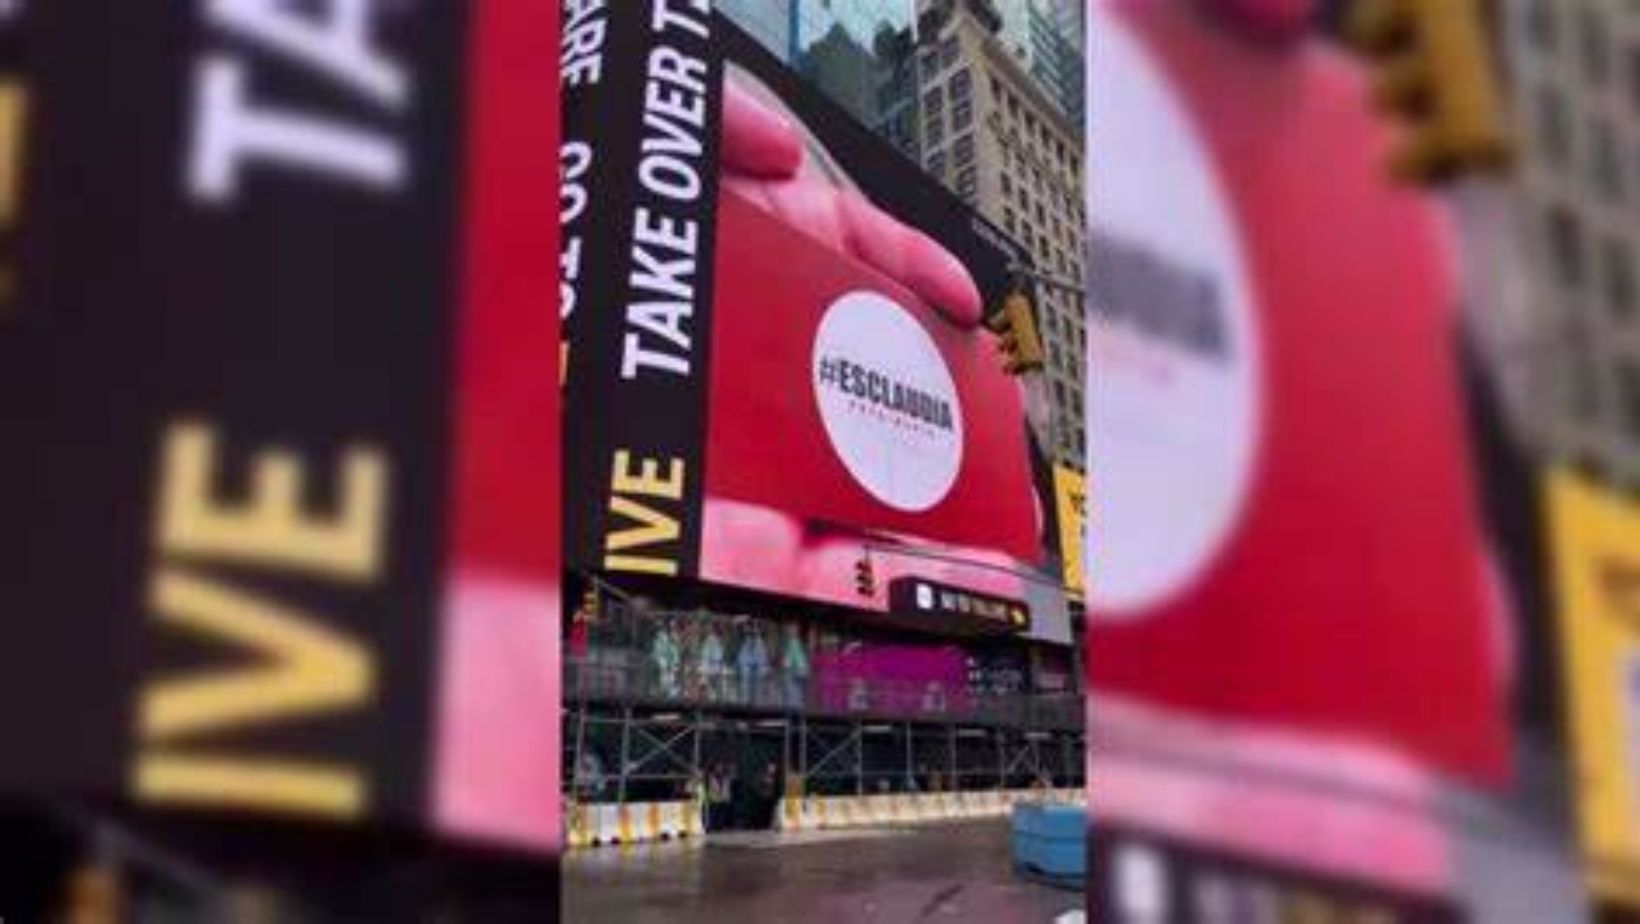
[563, 821, 1082, 924]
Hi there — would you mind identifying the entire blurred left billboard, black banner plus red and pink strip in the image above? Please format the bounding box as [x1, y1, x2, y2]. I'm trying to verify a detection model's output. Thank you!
[0, 2, 559, 865]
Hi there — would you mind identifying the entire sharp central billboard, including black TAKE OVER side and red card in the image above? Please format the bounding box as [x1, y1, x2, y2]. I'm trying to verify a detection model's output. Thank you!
[564, 5, 1069, 642]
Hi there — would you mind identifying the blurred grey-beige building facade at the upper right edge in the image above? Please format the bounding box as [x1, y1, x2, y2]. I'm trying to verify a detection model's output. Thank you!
[1501, 0, 1640, 486]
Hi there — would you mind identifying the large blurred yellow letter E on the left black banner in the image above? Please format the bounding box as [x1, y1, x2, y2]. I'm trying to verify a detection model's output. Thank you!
[159, 423, 387, 581]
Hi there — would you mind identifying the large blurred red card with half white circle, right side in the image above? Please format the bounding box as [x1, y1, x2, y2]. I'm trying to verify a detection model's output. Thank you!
[1089, 0, 1506, 780]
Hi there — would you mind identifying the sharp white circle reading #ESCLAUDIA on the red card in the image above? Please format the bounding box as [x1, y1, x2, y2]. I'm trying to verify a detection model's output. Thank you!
[812, 290, 963, 512]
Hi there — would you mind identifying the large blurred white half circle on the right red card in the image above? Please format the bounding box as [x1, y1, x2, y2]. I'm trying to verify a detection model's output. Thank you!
[1087, 2, 1261, 619]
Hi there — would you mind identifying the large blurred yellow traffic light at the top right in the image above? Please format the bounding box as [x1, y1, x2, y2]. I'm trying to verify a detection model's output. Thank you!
[1345, 0, 1512, 182]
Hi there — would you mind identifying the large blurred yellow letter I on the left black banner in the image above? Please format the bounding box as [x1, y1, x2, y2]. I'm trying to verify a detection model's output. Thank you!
[136, 752, 364, 817]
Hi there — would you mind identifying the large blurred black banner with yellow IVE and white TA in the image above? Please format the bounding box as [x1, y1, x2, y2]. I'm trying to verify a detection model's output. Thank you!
[0, 0, 467, 819]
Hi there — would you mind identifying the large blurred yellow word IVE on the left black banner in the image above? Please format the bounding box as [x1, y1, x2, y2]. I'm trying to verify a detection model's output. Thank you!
[133, 423, 389, 817]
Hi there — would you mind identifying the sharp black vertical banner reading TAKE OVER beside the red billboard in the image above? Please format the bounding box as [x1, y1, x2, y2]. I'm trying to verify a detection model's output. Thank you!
[559, 0, 722, 574]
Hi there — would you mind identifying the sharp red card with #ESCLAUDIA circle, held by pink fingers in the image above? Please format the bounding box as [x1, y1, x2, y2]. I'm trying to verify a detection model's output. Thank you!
[707, 190, 1040, 560]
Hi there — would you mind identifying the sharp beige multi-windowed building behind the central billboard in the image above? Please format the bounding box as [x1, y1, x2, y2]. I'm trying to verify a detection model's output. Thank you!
[917, 0, 1087, 466]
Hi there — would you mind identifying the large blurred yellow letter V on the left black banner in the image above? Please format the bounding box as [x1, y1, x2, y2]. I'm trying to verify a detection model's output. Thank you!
[139, 566, 374, 742]
